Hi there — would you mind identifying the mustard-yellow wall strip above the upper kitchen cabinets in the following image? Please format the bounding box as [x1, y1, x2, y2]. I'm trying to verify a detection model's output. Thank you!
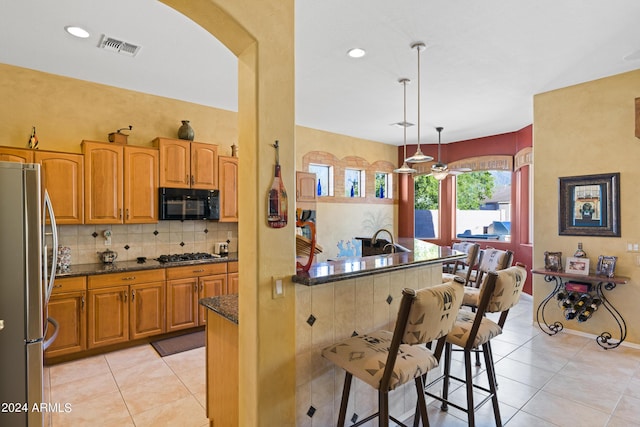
[0, 64, 238, 155]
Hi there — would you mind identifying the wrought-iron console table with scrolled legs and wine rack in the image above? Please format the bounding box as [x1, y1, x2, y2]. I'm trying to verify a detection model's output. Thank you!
[531, 269, 629, 350]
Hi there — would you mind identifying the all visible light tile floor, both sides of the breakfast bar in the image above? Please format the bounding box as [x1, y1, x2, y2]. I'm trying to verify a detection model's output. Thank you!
[46, 296, 640, 427]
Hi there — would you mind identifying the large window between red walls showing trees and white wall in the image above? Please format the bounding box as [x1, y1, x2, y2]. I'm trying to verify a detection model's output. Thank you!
[456, 171, 512, 241]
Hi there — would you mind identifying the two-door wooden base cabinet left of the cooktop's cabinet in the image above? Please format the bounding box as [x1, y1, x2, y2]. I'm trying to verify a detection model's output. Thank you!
[87, 269, 165, 348]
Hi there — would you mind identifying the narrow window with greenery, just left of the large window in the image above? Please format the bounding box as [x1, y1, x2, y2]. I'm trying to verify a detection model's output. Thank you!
[413, 175, 440, 239]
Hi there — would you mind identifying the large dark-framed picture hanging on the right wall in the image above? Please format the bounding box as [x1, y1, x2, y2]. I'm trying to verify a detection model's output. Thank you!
[558, 172, 620, 237]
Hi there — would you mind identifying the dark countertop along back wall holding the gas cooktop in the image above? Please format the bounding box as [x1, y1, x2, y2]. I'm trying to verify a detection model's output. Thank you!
[56, 252, 238, 278]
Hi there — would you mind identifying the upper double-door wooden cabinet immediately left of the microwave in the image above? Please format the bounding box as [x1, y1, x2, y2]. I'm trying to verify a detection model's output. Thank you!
[82, 141, 158, 224]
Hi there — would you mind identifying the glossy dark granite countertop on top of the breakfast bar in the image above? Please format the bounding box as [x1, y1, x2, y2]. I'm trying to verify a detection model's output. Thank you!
[292, 238, 466, 286]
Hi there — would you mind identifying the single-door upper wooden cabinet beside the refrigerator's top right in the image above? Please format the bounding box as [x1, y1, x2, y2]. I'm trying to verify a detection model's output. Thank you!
[33, 150, 84, 224]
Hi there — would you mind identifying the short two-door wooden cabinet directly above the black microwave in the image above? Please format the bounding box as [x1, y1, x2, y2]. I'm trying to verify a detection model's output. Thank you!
[153, 138, 218, 190]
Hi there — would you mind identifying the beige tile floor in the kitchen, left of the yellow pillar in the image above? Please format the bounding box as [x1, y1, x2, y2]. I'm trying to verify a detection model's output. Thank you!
[45, 345, 209, 427]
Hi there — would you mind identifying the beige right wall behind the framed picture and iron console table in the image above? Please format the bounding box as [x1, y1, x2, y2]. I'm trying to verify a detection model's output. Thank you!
[533, 70, 640, 345]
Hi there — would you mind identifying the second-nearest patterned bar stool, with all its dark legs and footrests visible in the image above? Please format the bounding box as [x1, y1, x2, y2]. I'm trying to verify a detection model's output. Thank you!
[425, 265, 527, 426]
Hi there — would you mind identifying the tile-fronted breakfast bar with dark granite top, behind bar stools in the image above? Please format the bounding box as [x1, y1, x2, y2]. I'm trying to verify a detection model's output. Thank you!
[292, 239, 466, 425]
